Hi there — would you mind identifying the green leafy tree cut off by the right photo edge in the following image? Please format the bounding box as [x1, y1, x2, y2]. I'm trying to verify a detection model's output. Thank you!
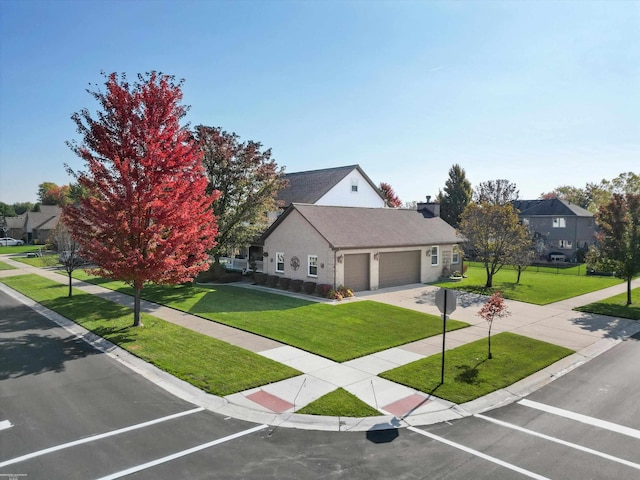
[587, 193, 640, 305]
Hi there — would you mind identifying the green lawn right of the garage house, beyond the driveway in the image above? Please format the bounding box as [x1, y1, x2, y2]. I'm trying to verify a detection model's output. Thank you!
[435, 263, 622, 305]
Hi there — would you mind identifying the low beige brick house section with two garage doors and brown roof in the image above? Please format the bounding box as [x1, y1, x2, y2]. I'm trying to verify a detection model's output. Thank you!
[262, 203, 462, 291]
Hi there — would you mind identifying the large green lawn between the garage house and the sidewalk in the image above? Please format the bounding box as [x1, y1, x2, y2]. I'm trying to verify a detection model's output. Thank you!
[74, 272, 468, 362]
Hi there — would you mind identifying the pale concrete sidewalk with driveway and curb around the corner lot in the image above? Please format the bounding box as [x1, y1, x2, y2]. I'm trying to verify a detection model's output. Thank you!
[0, 256, 640, 431]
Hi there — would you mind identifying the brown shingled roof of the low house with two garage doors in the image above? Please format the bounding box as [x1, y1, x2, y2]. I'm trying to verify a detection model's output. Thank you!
[261, 203, 461, 249]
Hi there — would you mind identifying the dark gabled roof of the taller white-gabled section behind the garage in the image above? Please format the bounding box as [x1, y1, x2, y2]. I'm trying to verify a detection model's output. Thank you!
[278, 165, 384, 207]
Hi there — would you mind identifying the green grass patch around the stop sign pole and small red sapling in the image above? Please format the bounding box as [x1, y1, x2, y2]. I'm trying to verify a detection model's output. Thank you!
[380, 332, 573, 404]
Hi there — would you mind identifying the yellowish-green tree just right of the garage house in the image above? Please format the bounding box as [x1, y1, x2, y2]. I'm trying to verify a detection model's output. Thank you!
[458, 203, 531, 288]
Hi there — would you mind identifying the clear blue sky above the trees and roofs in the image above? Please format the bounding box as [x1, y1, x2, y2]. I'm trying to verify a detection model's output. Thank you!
[0, 0, 640, 204]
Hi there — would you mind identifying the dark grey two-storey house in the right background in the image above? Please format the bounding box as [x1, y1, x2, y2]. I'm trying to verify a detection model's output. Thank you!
[512, 198, 596, 262]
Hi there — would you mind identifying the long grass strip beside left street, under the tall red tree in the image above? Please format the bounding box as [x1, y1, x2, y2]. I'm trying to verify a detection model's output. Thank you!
[2, 275, 300, 396]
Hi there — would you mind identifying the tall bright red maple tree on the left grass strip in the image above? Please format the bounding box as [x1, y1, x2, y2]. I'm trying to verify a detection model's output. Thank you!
[63, 72, 217, 326]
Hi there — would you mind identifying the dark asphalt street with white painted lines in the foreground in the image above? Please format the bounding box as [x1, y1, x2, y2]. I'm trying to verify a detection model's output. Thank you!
[0, 293, 640, 480]
